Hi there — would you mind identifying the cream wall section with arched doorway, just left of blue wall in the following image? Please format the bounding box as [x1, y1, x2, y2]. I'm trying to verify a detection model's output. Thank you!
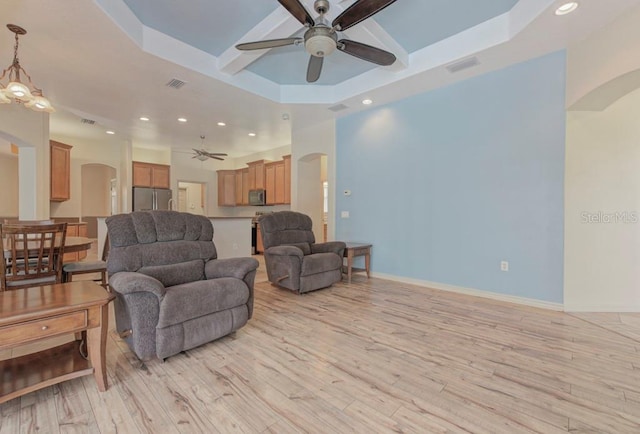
[291, 120, 336, 240]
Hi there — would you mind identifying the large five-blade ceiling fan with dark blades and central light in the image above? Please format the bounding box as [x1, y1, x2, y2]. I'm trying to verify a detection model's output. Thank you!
[236, 0, 396, 83]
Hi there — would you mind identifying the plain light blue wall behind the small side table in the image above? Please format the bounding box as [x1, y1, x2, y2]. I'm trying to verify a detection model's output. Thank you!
[336, 51, 566, 303]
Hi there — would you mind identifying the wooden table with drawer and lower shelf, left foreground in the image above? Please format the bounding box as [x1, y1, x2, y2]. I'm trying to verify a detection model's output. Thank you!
[0, 281, 115, 403]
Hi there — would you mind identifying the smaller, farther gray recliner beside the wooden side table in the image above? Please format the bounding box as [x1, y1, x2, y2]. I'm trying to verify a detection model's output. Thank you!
[259, 211, 346, 293]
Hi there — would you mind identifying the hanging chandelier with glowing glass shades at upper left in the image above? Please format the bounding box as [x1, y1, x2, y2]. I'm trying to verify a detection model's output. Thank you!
[0, 24, 55, 113]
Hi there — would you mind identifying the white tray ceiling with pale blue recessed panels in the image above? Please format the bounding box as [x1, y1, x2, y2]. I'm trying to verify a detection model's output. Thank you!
[0, 0, 640, 156]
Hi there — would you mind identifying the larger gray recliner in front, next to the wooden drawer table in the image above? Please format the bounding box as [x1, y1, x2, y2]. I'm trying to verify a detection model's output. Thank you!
[106, 211, 258, 360]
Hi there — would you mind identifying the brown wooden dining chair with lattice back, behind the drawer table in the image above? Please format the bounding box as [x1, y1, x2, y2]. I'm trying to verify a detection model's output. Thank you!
[0, 223, 67, 291]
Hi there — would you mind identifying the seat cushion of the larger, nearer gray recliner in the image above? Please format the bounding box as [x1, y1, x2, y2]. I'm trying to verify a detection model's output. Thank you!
[157, 277, 249, 328]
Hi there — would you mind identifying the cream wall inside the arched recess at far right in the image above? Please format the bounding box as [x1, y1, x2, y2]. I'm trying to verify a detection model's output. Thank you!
[564, 86, 640, 312]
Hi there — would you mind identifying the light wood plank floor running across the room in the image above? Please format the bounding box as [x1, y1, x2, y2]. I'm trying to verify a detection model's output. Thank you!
[0, 249, 640, 434]
